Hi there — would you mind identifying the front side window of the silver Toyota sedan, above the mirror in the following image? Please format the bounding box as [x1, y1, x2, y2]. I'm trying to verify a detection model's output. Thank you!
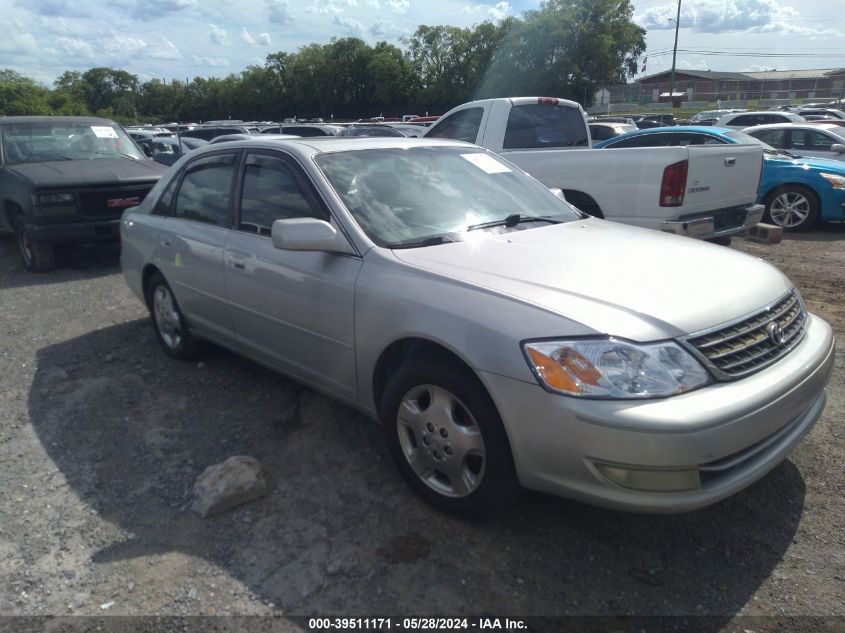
[238, 154, 326, 235]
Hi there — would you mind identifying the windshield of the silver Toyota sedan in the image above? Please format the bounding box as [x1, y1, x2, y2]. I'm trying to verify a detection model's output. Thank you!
[316, 147, 581, 248]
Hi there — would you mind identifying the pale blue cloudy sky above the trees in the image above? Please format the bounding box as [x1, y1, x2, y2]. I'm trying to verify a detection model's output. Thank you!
[0, 0, 845, 86]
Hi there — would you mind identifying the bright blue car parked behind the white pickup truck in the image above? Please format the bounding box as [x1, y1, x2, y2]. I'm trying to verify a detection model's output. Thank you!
[593, 125, 845, 231]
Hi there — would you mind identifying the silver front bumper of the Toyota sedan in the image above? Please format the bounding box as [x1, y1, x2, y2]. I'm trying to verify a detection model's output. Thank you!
[481, 315, 834, 512]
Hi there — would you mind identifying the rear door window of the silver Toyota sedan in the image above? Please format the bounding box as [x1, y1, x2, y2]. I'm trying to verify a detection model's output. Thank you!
[173, 153, 237, 226]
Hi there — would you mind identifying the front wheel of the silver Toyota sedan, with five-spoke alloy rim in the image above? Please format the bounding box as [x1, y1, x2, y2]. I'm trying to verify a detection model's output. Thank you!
[380, 358, 520, 517]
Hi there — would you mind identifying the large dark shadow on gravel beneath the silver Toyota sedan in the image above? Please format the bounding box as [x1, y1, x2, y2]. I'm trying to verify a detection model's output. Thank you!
[28, 320, 805, 631]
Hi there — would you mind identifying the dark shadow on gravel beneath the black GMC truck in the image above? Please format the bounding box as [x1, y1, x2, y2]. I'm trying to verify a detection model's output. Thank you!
[0, 234, 120, 288]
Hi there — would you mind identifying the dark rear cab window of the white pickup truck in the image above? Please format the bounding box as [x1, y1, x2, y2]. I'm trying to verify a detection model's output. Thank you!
[502, 103, 587, 149]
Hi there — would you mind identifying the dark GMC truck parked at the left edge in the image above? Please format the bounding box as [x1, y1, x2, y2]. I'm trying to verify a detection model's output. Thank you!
[0, 116, 167, 271]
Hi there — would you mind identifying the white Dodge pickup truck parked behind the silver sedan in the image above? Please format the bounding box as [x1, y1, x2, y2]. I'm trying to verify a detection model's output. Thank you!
[425, 97, 763, 239]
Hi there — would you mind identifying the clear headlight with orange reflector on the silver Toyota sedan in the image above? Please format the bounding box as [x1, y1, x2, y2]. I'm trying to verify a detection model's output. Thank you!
[523, 338, 710, 398]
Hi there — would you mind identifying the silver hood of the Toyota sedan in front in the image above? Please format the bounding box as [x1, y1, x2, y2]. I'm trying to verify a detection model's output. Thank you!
[393, 219, 792, 341]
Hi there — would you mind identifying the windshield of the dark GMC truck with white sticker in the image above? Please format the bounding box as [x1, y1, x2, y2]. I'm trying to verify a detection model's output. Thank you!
[0, 121, 144, 165]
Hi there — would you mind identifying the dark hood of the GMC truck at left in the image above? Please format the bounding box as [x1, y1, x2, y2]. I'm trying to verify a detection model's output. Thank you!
[8, 158, 167, 189]
